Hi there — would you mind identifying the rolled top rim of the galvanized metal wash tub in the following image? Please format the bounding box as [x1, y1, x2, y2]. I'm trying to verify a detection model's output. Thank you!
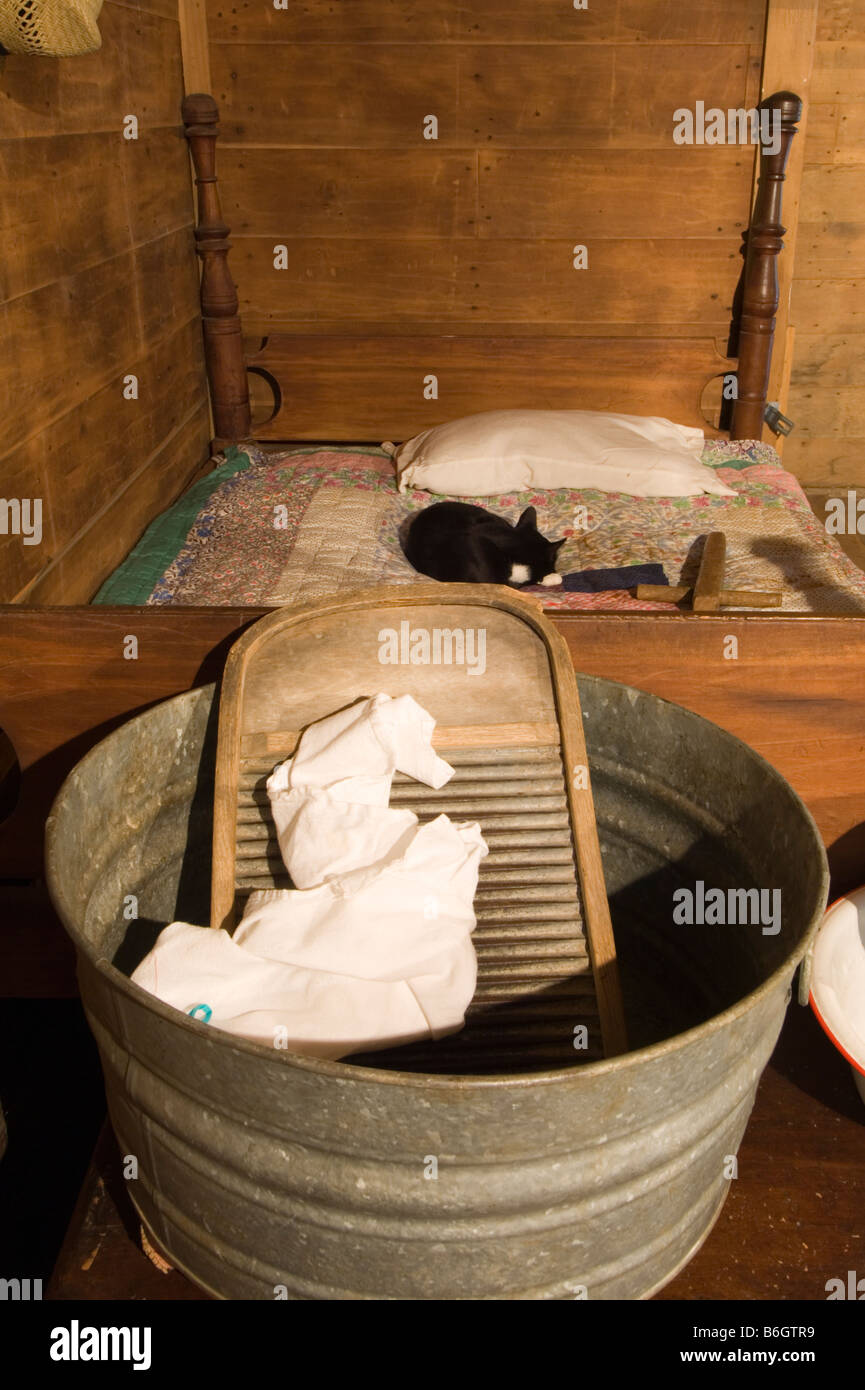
[45, 671, 830, 1093]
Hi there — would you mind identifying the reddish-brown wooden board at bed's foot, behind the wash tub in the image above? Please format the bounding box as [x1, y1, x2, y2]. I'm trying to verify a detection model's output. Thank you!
[0, 607, 865, 892]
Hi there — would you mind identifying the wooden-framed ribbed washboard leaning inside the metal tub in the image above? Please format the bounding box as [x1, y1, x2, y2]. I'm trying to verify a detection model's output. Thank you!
[211, 584, 627, 1073]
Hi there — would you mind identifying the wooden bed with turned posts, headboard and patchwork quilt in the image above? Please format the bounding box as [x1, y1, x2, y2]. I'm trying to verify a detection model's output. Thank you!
[84, 84, 865, 613]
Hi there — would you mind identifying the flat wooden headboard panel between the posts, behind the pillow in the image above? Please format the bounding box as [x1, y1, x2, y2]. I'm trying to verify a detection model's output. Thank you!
[249, 334, 727, 441]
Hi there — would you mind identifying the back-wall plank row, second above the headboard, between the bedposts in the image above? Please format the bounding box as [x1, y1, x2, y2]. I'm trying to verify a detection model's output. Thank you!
[220, 146, 751, 241]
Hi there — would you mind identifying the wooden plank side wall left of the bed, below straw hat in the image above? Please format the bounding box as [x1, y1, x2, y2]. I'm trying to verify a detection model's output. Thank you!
[0, 0, 210, 603]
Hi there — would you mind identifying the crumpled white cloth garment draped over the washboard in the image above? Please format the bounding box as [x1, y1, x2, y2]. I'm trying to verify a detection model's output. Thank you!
[132, 695, 487, 1058]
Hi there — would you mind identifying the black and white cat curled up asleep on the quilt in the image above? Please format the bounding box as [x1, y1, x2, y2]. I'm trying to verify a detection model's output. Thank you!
[402, 502, 565, 587]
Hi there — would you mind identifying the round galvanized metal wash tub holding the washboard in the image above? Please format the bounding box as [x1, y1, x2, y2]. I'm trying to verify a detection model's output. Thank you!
[47, 676, 827, 1298]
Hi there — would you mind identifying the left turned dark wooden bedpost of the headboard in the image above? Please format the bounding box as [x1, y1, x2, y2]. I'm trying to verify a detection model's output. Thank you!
[182, 92, 252, 450]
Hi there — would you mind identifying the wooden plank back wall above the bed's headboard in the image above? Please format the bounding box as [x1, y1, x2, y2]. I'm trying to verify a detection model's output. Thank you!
[207, 0, 766, 418]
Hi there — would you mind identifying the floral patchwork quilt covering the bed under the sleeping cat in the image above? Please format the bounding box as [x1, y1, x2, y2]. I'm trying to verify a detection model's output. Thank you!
[95, 441, 865, 613]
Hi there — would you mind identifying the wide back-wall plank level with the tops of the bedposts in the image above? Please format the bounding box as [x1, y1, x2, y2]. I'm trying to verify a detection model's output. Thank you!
[210, 42, 759, 150]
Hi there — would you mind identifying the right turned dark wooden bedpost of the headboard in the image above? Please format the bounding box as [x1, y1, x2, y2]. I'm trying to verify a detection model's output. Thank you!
[730, 92, 802, 439]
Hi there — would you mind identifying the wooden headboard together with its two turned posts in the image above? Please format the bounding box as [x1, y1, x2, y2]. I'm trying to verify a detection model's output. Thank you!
[184, 77, 802, 446]
